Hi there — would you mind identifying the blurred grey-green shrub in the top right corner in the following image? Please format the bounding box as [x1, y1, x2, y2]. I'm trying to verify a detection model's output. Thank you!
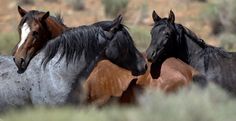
[203, 0, 236, 34]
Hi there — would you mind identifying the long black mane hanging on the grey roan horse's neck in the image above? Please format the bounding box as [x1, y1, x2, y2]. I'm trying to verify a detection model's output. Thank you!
[42, 26, 102, 67]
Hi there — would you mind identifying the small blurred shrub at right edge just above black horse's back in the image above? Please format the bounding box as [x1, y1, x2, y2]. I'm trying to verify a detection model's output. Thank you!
[219, 33, 236, 51]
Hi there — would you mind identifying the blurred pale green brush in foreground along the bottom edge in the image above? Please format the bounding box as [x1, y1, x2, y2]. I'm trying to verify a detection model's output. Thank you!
[1, 85, 236, 121]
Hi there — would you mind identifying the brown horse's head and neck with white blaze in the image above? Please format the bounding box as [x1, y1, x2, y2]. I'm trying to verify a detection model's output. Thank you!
[12, 6, 69, 73]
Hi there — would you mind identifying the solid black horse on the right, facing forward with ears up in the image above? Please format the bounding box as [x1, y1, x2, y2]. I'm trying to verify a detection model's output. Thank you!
[146, 11, 236, 94]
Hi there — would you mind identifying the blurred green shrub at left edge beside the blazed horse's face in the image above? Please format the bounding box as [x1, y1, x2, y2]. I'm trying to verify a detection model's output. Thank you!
[0, 33, 19, 55]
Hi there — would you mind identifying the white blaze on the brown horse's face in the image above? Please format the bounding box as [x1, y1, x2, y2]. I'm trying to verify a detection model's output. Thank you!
[18, 23, 30, 48]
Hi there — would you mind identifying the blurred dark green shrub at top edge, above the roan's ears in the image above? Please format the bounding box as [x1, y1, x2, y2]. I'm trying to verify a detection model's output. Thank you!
[102, 0, 129, 17]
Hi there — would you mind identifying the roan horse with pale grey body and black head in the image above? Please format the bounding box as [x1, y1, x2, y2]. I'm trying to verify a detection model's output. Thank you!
[0, 6, 146, 109]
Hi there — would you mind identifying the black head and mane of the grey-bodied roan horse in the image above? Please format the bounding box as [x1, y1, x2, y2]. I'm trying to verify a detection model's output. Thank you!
[43, 16, 147, 76]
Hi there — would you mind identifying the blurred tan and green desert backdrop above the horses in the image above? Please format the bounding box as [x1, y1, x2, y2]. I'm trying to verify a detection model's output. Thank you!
[0, 0, 236, 55]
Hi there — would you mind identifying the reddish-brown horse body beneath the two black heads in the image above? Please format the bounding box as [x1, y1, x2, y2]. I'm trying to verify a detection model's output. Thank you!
[84, 58, 198, 105]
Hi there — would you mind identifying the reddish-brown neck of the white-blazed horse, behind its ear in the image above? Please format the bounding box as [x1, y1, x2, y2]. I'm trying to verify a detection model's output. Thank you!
[46, 18, 68, 38]
